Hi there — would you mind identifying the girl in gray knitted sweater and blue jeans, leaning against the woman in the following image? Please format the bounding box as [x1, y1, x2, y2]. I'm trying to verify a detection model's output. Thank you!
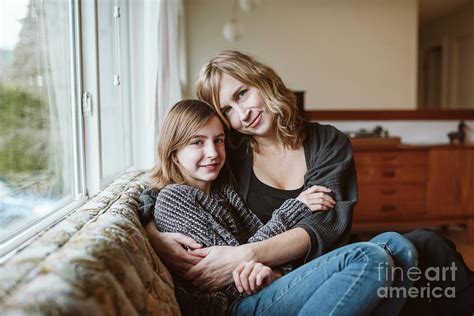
[152, 100, 416, 315]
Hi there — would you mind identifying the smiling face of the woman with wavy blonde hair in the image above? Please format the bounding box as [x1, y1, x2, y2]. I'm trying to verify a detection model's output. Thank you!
[219, 73, 273, 136]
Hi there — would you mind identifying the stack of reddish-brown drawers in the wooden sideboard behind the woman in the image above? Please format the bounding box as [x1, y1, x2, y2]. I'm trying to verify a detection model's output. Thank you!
[354, 148, 428, 221]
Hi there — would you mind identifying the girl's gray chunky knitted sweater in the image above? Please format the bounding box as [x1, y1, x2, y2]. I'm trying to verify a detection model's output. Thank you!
[155, 184, 311, 315]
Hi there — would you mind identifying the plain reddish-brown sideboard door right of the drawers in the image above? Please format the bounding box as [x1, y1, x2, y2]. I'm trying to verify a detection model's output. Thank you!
[427, 148, 474, 216]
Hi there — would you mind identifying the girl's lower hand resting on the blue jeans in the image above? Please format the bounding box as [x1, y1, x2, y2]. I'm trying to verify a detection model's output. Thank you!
[232, 260, 279, 295]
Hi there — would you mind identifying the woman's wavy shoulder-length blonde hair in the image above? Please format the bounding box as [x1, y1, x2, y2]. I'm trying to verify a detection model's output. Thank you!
[195, 51, 306, 149]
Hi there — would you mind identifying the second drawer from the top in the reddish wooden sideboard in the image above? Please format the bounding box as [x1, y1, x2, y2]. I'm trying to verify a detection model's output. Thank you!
[356, 165, 427, 184]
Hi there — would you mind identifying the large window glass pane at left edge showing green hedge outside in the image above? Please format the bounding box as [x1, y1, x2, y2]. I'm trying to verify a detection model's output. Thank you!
[0, 0, 75, 243]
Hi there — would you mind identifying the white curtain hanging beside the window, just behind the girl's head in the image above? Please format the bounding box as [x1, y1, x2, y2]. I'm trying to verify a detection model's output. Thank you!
[131, 0, 187, 169]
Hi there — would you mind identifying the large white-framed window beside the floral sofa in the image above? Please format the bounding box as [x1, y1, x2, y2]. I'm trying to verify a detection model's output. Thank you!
[0, 0, 143, 257]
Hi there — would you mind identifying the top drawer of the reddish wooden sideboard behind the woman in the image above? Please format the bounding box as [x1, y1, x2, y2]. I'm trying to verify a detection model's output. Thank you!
[354, 151, 428, 168]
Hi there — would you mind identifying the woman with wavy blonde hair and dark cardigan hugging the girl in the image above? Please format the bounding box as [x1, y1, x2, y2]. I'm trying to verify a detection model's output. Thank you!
[143, 51, 474, 310]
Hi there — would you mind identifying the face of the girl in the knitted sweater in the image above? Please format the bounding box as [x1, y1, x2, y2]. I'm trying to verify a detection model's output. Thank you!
[176, 116, 225, 192]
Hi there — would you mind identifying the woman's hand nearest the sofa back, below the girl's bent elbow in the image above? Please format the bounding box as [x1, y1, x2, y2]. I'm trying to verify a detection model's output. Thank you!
[145, 221, 203, 274]
